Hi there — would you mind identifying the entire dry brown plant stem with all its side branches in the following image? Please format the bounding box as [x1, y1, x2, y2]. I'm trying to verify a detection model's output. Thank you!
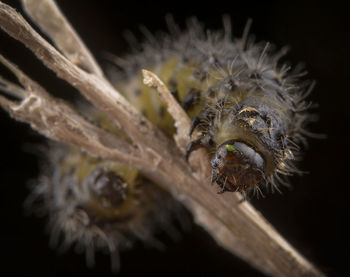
[0, 1, 322, 276]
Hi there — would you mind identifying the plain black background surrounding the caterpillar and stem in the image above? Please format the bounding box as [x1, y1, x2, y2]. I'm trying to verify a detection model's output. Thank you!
[0, 0, 350, 276]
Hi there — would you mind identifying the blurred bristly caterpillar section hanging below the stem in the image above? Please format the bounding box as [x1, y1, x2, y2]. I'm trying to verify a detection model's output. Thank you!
[26, 143, 186, 272]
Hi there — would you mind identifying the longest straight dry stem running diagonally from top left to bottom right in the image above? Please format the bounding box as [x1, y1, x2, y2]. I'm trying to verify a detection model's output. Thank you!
[0, 3, 322, 276]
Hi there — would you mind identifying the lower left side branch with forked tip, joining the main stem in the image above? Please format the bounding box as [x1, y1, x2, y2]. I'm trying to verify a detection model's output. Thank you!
[0, 55, 142, 164]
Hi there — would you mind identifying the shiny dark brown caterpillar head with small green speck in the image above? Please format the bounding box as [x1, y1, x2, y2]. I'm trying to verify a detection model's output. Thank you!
[211, 140, 265, 192]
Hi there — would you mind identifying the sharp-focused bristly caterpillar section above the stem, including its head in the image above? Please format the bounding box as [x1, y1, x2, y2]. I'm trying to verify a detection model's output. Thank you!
[110, 20, 312, 193]
